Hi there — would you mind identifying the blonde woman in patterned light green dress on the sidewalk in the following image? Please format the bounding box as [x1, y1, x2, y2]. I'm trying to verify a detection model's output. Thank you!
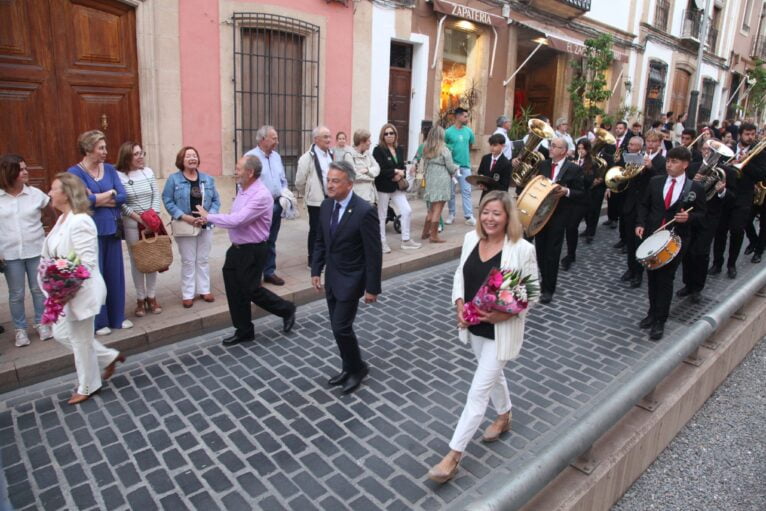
[421, 124, 459, 243]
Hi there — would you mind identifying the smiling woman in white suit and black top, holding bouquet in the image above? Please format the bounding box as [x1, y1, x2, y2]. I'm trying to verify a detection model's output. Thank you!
[428, 191, 539, 483]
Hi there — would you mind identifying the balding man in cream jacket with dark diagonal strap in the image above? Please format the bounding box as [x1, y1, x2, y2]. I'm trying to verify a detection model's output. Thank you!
[295, 126, 333, 267]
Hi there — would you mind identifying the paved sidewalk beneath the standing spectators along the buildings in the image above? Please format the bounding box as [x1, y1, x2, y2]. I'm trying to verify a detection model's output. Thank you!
[0, 196, 478, 392]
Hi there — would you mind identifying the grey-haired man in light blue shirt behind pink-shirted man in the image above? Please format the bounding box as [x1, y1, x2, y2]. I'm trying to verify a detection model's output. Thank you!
[245, 125, 287, 286]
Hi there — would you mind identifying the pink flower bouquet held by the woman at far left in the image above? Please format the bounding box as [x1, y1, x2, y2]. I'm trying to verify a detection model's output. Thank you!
[38, 254, 90, 325]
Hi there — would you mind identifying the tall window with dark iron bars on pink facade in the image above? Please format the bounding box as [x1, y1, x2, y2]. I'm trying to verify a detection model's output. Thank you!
[232, 13, 319, 185]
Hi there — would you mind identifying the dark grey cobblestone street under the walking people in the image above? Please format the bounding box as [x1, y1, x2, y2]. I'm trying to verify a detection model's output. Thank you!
[0, 229, 760, 511]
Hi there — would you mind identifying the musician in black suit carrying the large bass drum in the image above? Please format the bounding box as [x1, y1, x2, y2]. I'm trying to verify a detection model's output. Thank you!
[535, 138, 585, 303]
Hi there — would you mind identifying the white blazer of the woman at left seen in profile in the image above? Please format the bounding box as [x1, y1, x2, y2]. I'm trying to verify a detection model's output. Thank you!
[38, 213, 106, 320]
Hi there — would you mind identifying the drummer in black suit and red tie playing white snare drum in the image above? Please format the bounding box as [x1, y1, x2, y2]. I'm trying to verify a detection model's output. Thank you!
[635, 147, 706, 341]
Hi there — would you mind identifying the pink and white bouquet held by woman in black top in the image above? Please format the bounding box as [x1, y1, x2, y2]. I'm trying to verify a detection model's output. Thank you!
[463, 268, 539, 325]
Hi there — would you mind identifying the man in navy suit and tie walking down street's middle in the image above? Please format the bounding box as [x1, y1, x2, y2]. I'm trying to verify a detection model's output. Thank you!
[311, 161, 383, 394]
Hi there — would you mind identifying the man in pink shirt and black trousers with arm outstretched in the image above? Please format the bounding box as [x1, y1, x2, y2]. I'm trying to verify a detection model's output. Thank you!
[197, 156, 296, 346]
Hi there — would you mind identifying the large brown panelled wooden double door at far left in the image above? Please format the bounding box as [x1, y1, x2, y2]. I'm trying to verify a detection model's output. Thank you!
[0, 0, 141, 190]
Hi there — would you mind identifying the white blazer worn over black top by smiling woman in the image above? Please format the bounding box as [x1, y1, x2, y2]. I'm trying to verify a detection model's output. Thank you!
[452, 231, 540, 360]
